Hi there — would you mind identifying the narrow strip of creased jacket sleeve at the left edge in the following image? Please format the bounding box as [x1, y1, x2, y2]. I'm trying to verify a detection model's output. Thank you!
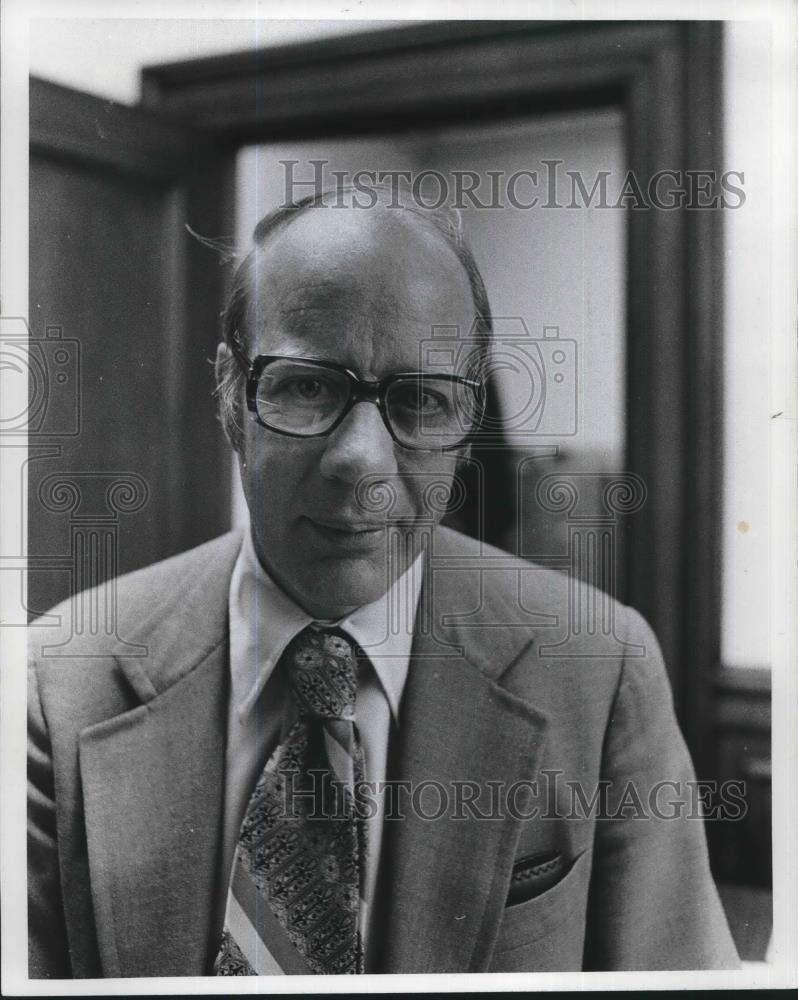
[28, 664, 72, 979]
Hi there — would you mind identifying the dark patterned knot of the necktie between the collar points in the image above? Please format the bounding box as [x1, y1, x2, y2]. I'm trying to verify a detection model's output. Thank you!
[283, 625, 357, 719]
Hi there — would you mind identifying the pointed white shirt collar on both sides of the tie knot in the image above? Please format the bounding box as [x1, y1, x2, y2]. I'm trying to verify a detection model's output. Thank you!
[229, 528, 424, 721]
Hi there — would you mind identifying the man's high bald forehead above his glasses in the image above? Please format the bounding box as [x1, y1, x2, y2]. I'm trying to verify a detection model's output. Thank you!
[250, 206, 474, 373]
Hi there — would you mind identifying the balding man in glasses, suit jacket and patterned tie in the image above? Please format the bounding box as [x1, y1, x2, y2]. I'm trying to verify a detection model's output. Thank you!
[29, 188, 737, 977]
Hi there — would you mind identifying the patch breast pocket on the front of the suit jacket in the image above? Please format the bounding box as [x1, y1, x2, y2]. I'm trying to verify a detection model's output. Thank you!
[490, 851, 592, 972]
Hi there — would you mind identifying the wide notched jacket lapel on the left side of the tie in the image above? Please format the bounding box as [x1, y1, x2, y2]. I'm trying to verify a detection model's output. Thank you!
[80, 541, 237, 976]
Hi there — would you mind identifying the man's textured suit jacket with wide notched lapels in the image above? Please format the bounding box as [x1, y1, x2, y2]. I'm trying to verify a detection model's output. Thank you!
[28, 528, 737, 977]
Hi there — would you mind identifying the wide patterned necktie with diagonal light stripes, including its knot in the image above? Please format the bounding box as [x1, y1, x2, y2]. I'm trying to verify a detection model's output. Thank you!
[214, 625, 366, 976]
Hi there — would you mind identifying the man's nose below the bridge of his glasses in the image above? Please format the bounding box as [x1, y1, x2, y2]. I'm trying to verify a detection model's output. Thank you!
[319, 401, 397, 486]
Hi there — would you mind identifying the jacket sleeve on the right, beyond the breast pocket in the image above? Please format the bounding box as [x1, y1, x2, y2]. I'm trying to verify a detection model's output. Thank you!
[584, 609, 739, 970]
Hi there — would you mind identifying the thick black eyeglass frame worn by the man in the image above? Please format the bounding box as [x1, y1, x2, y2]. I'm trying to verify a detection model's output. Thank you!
[230, 339, 485, 452]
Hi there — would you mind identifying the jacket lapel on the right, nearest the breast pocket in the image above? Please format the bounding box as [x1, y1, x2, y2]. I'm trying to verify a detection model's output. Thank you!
[381, 528, 547, 972]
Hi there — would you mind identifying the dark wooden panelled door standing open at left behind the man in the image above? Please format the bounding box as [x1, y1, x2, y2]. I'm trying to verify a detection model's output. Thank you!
[28, 80, 232, 615]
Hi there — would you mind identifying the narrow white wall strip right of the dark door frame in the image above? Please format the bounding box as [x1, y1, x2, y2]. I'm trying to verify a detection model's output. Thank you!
[722, 21, 777, 666]
